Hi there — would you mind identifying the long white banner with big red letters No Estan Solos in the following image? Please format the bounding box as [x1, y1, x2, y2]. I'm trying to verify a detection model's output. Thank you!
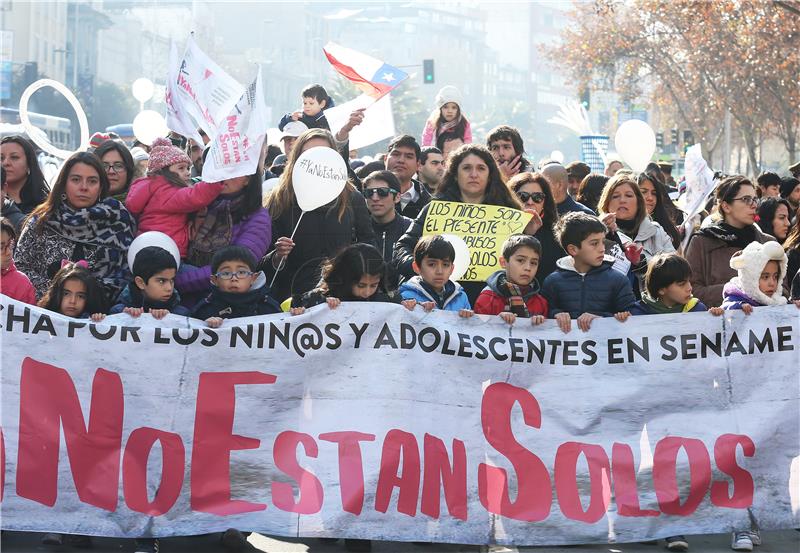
[0, 296, 800, 545]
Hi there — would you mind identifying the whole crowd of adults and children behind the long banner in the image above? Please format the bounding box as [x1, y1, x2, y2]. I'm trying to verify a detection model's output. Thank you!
[0, 85, 800, 551]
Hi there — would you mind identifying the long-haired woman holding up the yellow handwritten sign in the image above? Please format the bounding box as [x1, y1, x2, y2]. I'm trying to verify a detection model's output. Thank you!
[394, 144, 537, 305]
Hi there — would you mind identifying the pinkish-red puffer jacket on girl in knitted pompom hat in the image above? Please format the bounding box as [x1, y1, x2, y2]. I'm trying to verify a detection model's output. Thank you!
[125, 176, 223, 259]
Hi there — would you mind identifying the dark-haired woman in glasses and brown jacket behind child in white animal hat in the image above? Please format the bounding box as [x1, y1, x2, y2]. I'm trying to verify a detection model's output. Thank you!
[686, 175, 774, 307]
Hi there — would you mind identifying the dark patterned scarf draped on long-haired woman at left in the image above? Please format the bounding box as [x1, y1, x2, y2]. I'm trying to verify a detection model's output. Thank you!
[44, 198, 136, 288]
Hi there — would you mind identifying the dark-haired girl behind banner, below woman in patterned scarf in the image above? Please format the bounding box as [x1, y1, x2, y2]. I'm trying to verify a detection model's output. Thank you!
[39, 261, 106, 323]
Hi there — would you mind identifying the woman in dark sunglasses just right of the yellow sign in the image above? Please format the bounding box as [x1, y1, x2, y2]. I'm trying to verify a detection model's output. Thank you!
[507, 173, 567, 283]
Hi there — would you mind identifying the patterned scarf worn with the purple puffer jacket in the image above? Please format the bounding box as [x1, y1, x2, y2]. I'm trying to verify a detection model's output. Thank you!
[187, 193, 244, 267]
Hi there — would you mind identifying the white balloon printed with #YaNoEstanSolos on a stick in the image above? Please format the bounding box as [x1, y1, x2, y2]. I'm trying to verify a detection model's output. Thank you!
[292, 146, 347, 211]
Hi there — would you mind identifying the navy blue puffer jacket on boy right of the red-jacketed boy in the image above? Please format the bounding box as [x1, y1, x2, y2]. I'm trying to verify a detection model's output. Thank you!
[542, 256, 636, 318]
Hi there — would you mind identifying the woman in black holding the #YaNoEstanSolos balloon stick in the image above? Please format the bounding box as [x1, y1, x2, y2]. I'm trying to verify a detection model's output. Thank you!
[264, 129, 375, 300]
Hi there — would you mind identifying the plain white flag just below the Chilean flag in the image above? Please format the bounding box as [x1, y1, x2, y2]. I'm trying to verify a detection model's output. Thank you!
[325, 94, 395, 150]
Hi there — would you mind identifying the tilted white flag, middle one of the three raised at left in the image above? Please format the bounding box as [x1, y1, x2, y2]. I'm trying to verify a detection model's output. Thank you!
[170, 36, 244, 138]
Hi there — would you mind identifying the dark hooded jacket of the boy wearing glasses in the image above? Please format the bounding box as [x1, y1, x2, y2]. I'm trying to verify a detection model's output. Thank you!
[192, 272, 281, 320]
